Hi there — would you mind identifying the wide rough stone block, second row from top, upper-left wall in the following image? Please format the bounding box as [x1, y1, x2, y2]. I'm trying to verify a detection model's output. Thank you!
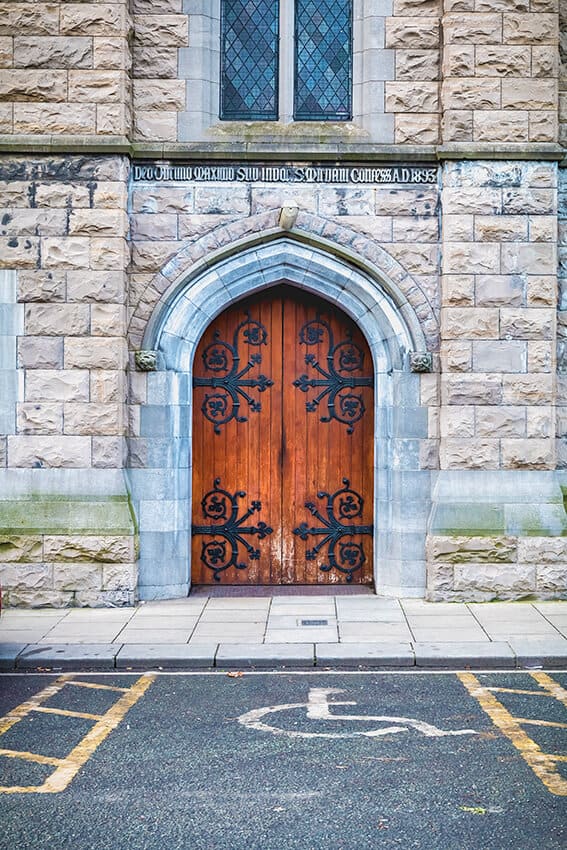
[14, 35, 93, 68]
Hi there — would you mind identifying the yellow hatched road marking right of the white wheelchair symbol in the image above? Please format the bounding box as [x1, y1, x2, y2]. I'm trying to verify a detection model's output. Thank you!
[457, 673, 567, 797]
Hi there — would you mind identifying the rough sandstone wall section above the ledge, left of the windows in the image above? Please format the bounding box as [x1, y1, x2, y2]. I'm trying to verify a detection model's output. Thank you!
[0, 0, 131, 141]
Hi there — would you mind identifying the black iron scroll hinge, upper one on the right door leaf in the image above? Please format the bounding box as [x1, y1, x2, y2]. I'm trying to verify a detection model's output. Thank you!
[293, 314, 374, 434]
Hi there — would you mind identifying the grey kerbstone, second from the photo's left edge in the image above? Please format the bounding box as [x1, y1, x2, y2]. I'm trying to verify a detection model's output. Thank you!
[16, 643, 118, 670]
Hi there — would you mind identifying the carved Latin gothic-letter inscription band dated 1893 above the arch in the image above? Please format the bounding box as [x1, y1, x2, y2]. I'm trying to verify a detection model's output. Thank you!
[132, 162, 438, 184]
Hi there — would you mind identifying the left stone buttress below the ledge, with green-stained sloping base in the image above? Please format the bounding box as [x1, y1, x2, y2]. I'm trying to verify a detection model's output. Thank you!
[0, 156, 136, 604]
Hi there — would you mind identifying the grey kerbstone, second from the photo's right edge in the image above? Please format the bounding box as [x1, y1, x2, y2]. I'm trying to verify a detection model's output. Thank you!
[413, 641, 516, 670]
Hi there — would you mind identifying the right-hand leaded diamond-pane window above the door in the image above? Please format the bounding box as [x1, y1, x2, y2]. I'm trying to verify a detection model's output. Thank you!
[294, 0, 352, 121]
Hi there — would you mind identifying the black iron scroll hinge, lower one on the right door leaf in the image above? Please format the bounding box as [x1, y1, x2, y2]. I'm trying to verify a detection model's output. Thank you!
[293, 478, 372, 582]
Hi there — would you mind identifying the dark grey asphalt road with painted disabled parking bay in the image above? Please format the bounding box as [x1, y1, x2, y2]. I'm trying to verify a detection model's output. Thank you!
[0, 672, 567, 850]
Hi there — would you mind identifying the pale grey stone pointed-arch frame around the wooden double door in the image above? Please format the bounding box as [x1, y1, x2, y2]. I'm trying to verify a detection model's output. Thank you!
[132, 231, 430, 599]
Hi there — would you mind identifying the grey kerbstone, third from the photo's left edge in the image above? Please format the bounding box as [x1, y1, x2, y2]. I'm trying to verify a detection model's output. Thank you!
[116, 643, 218, 670]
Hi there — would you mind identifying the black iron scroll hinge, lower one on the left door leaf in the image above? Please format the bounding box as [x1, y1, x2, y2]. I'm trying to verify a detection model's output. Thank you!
[191, 478, 273, 581]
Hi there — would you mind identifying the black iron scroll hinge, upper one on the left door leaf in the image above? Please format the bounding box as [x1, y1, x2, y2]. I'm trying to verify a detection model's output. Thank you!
[193, 311, 274, 434]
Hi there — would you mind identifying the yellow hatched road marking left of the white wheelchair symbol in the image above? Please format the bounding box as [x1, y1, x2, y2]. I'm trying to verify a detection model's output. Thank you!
[0, 673, 155, 794]
